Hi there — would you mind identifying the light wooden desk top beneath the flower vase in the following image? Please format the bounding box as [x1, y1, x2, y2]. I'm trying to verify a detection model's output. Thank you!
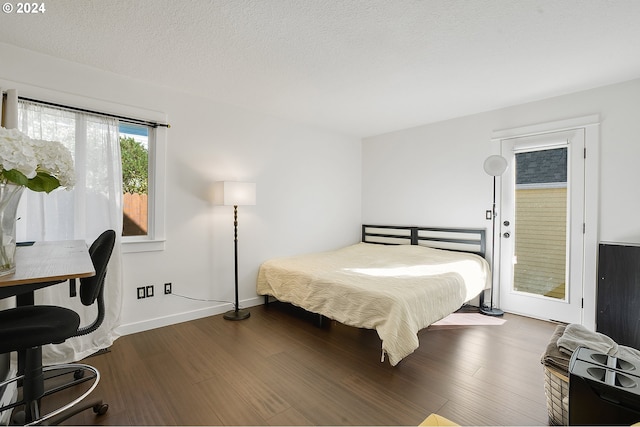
[0, 240, 96, 299]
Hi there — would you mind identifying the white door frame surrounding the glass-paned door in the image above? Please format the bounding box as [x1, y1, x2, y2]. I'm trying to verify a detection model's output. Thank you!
[491, 114, 600, 330]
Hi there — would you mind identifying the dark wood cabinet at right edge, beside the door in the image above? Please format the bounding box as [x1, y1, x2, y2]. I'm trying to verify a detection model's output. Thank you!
[596, 243, 640, 349]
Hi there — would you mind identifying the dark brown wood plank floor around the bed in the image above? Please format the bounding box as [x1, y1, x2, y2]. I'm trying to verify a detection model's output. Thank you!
[45, 304, 555, 425]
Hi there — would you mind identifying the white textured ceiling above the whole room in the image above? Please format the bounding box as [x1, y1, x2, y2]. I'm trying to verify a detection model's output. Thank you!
[0, 0, 640, 136]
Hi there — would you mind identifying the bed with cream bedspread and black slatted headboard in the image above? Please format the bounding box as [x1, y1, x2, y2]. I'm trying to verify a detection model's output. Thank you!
[257, 225, 490, 366]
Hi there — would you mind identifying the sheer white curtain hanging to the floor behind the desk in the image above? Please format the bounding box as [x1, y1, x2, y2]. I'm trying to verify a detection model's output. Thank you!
[16, 100, 122, 364]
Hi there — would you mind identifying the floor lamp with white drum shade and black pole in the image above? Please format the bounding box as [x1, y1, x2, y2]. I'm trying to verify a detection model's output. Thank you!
[213, 181, 256, 320]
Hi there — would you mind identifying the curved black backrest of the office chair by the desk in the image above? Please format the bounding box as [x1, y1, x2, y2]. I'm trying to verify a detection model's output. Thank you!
[74, 230, 116, 337]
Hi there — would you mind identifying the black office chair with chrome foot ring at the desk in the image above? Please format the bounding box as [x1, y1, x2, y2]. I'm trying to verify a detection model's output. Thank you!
[0, 230, 116, 425]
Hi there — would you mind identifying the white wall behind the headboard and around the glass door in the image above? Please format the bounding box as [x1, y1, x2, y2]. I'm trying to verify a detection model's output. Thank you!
[362, 80, 640, 324]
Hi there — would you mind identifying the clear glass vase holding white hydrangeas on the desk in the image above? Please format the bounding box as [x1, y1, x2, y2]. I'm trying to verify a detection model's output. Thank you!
[0, 183, 24, 276]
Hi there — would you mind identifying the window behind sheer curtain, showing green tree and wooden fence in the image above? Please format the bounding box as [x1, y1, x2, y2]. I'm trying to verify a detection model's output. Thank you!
[19, 100, 166, 253]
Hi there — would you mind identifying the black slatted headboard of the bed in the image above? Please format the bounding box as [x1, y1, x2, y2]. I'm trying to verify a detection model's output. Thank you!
[362, 224, 486, 257]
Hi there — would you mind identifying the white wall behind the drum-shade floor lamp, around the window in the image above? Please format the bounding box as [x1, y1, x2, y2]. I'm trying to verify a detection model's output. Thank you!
[0, 43, 361, 333]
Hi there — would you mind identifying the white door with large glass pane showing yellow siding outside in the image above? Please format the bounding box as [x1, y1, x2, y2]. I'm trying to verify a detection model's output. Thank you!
[500, 130, 584, 323]
